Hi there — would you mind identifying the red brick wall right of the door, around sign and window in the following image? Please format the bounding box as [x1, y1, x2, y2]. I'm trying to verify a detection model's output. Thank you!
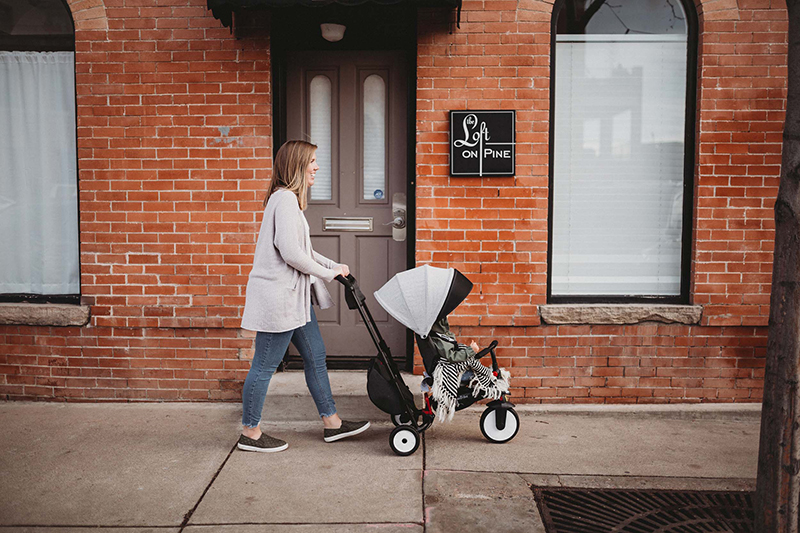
[417, 0, 787, 402]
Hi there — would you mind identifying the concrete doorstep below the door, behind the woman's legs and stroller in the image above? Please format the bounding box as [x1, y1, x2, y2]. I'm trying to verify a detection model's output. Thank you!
[261, 370, 422, 422]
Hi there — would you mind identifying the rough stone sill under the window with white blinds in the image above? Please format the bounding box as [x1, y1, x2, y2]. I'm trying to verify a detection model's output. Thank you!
[539, 304, 703, 324]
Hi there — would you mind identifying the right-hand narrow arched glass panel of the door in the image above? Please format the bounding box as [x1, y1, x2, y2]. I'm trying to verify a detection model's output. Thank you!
[363, 74, 386, 200]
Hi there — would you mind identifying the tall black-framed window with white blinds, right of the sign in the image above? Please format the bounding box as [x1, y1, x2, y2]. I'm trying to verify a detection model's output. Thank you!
[548, 0, 696, 303]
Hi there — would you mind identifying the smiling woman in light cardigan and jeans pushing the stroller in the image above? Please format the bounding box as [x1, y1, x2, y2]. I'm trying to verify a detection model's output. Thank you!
[238, 141, 369, 452]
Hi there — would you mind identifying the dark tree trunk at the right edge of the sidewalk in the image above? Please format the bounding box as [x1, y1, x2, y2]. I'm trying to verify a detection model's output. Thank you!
[755, 0, 800, 533]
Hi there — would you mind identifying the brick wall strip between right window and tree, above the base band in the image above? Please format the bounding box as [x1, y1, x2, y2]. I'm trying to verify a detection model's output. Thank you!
[692, 0, 788, 326]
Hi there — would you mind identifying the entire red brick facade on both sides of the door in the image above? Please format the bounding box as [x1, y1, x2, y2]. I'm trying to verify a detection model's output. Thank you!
[0, 0, 787, 403]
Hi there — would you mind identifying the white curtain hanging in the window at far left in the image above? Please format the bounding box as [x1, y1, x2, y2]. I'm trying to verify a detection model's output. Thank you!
[0, 52, 80, 294]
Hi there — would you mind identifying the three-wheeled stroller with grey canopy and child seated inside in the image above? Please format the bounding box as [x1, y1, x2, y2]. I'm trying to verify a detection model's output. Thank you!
[336, 265, 519, 455]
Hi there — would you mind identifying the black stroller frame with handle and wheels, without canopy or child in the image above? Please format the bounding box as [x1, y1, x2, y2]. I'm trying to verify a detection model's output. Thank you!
[336, 273, 519, 455]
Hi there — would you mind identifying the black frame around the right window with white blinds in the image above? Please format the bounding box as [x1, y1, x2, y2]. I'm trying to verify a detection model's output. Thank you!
[547, 0, 699, 304]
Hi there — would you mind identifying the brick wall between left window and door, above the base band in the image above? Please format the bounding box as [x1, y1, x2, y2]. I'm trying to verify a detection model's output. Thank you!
[76, 0, 271, 328]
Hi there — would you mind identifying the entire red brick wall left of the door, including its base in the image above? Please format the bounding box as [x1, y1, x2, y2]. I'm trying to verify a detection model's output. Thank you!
[0, 0, 272, 400]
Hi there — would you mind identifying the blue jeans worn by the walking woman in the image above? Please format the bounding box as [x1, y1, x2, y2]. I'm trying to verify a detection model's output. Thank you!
[242, 308, 336, 428]
